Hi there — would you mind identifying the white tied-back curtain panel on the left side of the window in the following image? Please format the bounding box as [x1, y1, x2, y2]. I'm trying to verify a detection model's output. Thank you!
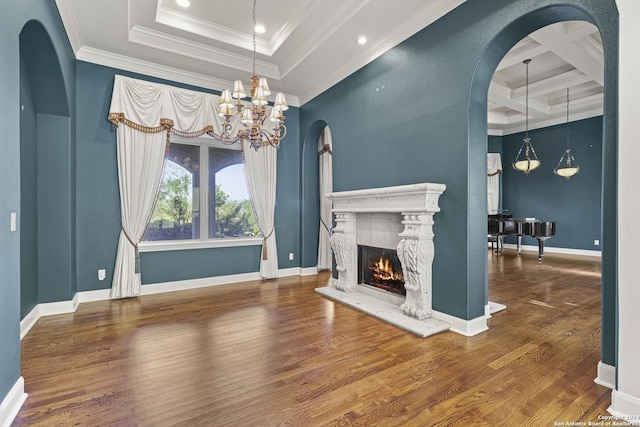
[111, 126, 167, 298]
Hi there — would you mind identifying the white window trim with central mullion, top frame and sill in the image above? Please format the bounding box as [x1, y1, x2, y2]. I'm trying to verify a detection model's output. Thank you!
[138, 135, 263, 252]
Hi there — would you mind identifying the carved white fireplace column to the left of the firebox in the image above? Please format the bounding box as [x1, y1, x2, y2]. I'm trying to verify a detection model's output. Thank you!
[330, 213, 358, 292]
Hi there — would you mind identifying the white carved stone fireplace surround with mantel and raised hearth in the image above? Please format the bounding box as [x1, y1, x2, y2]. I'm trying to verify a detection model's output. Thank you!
[316, 183, 450, 337]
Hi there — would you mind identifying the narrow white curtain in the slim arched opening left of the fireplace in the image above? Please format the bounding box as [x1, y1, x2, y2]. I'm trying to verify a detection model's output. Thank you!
[318, 126, 333, 270]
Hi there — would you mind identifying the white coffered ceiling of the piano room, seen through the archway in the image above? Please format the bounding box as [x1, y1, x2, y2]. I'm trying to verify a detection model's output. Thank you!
[488, 21, 604, 135]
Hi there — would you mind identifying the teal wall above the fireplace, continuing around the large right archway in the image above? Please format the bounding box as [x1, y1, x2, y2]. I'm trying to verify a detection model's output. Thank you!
[300, 0, 618, 365]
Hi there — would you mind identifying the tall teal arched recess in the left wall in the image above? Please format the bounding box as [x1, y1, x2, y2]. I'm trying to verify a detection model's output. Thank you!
[19, 21, 75, 318]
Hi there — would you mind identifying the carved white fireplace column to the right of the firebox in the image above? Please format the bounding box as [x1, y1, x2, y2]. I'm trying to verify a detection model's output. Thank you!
[398, 212, 434, 320]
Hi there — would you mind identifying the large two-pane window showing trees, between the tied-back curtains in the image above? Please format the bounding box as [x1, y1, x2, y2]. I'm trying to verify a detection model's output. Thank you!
[142, 135, 260, 249]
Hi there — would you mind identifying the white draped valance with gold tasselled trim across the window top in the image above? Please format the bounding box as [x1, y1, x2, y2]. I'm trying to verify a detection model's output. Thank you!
[109, 75, 239, 136]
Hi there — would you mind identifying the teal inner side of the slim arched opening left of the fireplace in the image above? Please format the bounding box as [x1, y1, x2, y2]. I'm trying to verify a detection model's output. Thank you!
[300, 120, 328, 268]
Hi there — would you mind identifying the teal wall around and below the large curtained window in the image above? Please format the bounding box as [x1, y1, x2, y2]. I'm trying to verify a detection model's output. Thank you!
[76, 61, 300, 291]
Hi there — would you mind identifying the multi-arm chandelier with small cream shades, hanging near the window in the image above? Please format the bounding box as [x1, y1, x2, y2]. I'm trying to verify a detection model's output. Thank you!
[212, 0, 289, 150]
